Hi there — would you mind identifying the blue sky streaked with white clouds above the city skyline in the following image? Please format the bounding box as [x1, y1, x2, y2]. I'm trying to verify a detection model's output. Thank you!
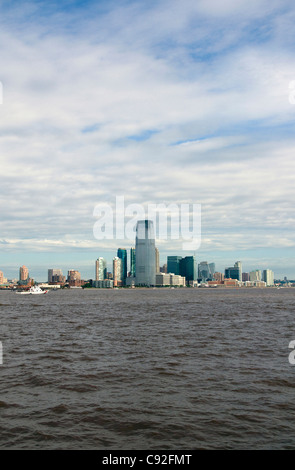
[0, 0, 295, 280]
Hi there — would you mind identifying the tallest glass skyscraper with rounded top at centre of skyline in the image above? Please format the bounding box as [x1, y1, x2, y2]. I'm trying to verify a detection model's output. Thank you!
[135, 220, 156, 286]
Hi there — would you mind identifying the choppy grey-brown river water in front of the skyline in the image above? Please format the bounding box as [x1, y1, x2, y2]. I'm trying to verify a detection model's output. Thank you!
[0, 288, 295, 450]
